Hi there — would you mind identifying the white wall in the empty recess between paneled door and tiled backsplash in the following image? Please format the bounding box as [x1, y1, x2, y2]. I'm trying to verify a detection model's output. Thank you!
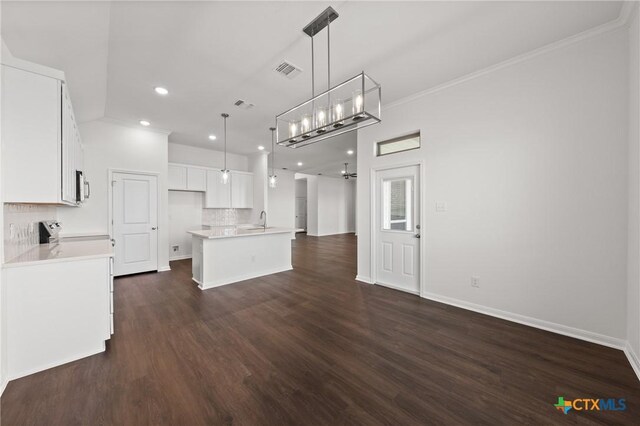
[169, 191, 204, 260]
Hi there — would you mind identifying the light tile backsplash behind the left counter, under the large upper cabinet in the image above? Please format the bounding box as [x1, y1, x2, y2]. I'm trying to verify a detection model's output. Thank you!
[3, 204, 56, 261]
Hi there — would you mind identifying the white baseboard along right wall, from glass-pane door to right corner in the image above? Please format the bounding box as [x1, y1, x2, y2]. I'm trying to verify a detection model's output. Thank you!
[421, 292, 627, 350]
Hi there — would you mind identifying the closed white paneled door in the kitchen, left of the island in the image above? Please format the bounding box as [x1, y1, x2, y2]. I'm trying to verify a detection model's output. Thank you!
[112, 173, 158, 275]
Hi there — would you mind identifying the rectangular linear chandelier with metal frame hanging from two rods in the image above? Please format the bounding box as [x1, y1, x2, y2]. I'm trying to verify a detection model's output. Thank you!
[276, 7, 382, 148]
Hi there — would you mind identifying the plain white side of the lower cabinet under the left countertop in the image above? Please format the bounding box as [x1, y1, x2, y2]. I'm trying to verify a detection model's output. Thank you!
[3, 257, 113, 380]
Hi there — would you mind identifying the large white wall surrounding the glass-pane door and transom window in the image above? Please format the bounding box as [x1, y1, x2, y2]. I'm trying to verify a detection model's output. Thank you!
[357, 29, 628, 344]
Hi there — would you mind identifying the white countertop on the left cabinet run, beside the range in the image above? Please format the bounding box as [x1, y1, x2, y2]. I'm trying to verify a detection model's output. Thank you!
[3, 238, 113, 268]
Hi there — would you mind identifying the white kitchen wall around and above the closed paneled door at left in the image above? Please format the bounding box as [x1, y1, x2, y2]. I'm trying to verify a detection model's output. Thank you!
[58, 120, 169, 270]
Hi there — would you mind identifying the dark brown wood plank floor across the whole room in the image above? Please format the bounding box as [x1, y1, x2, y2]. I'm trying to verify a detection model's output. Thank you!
[0, 235, 640, 426]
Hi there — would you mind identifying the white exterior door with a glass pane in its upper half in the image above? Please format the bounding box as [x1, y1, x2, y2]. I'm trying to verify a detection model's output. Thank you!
[375, 166, 420, 294]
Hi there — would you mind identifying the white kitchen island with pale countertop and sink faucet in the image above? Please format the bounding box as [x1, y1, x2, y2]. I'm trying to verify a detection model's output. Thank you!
[189, 226, 295, 290]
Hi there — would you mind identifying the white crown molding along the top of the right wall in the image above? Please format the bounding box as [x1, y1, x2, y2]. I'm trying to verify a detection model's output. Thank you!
[382, 1, 640, 111]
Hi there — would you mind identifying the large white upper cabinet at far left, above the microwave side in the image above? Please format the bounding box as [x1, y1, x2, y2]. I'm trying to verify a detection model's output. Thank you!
[1, 65, 82, 205]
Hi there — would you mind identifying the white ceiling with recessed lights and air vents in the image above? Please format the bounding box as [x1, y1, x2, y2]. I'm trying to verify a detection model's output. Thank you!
[1, 1, 621, 174]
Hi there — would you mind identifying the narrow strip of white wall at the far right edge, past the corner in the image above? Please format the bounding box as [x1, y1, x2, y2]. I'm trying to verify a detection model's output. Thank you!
[627, 4, 640, 368]
